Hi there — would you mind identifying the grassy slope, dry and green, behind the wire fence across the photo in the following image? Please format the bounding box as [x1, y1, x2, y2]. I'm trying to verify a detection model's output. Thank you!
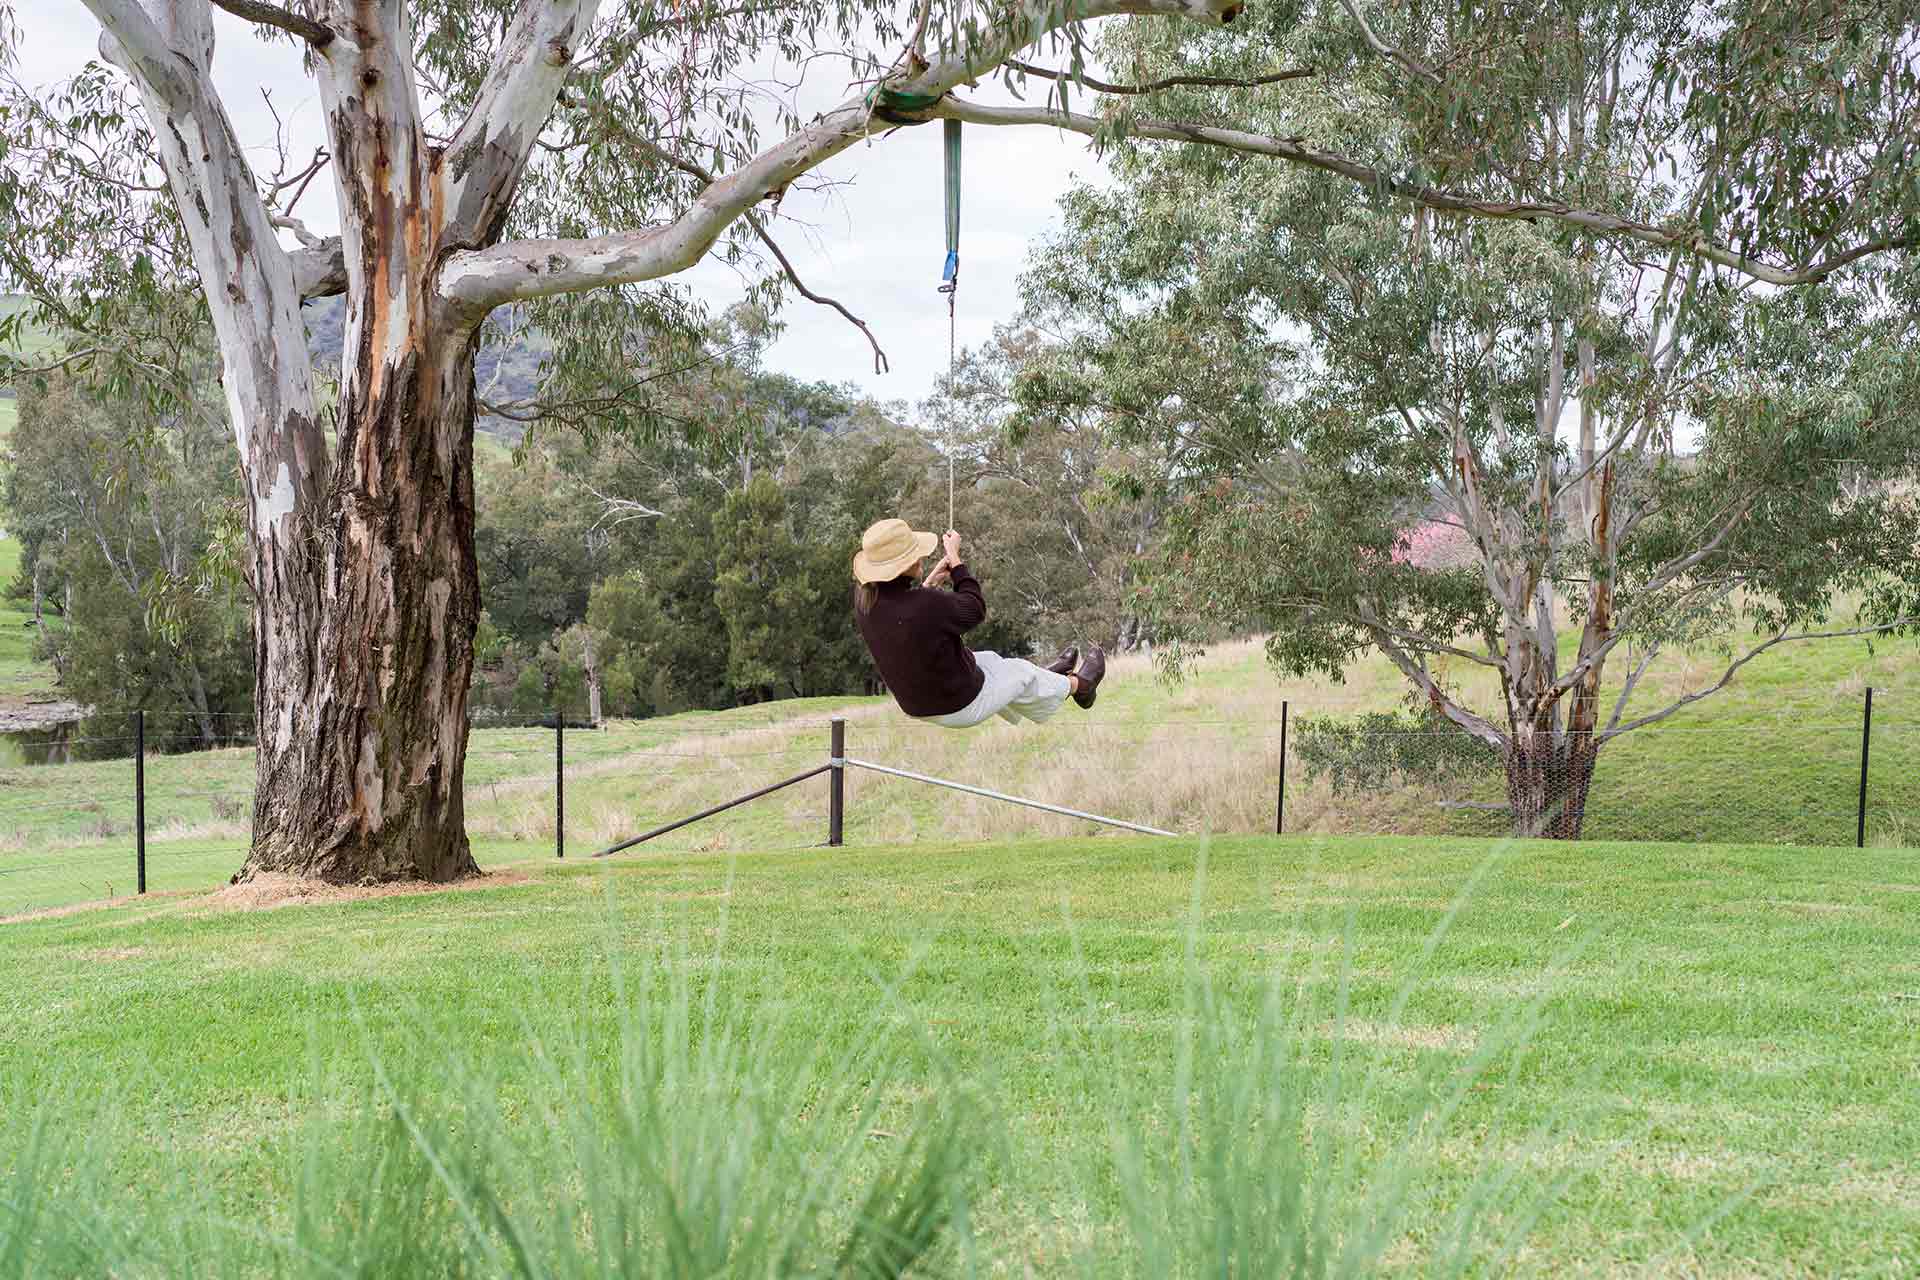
[0, 641, 1920, 912]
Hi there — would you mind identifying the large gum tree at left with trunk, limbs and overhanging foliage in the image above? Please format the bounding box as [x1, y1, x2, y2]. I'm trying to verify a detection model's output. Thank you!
[0, 0, 1912, 881]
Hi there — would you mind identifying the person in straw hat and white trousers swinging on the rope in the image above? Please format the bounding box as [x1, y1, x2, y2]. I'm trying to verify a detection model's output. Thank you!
[852, 520, 1106, 729]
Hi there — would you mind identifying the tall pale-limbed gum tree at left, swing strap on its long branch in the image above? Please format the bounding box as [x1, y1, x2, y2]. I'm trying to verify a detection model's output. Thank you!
[0, 0, 1910, 881]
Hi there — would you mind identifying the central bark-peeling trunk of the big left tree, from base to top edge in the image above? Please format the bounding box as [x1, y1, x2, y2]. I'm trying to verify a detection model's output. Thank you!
[240, 0, 480, 883]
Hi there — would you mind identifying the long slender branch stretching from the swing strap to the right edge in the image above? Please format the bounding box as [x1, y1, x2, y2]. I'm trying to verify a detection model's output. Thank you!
[927, 98, 1920, 286]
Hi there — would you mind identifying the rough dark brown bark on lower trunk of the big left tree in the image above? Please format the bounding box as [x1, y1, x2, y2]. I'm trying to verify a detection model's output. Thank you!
[242, 336, 480, 883]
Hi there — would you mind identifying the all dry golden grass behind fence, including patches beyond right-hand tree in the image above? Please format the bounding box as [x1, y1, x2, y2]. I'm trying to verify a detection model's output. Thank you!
[453, 641, 1920, 852]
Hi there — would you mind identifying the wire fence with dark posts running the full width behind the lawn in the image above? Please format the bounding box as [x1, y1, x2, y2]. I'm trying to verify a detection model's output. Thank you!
[0, 691, 1920, 919]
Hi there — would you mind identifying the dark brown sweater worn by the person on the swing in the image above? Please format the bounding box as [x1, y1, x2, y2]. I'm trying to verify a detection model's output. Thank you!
[852, 564, 987, 716]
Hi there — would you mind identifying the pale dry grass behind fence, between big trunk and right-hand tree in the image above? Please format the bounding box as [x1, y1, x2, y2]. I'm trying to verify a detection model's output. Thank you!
[456, 641, 1425, 852]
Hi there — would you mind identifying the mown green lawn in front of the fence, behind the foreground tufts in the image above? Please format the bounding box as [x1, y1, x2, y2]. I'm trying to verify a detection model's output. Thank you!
[0, 837, 1920, 1276]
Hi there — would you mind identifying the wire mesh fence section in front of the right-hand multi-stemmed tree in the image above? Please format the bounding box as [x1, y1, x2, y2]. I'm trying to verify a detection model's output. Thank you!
[1286, 691, 1920, 848]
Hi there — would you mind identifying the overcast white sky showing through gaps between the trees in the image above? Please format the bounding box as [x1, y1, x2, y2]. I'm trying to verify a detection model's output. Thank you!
[15, 0, 1098, 401]
